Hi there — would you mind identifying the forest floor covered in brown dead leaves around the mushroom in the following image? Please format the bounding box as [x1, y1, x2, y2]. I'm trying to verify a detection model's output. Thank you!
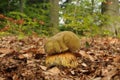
[0, 36, 120, 80]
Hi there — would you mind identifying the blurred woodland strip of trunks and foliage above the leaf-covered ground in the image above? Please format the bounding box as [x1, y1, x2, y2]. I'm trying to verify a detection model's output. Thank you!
[0, 0, 120, 37]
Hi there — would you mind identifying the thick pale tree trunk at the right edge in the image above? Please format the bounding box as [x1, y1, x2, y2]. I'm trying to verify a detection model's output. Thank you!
[102, 0, 120, 35]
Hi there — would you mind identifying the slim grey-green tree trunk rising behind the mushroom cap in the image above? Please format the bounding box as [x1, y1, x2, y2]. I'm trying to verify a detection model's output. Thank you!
[50, 0, 59, 34]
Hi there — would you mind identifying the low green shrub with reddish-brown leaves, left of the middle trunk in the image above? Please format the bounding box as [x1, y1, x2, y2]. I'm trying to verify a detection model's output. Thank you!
[2, 12, 47, 35]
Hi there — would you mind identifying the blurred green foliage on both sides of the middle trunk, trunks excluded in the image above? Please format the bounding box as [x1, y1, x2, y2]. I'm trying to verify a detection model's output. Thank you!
[0, 0, 119, 36]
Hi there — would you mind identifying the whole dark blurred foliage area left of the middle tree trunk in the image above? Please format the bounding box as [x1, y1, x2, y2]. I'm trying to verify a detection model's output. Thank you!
[0, 0, 49, 35]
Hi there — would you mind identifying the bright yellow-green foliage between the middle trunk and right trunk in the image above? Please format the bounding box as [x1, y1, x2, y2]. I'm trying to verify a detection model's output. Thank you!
[60, 0, 113, 36]
